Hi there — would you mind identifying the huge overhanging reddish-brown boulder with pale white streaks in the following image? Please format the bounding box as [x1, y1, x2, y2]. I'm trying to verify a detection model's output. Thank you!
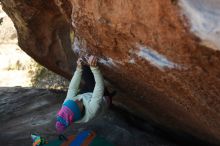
[1, 0, 220, 144]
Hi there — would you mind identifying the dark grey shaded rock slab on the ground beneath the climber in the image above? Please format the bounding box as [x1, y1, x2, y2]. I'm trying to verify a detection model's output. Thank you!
[0, 87, 212, 146]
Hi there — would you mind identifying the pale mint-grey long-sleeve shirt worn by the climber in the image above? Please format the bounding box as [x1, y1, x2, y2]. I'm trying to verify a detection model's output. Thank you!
[64, 67, 107, 123]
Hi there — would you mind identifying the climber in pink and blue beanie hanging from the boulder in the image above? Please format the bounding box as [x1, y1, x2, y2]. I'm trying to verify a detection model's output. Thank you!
[56, 56, 115, 134]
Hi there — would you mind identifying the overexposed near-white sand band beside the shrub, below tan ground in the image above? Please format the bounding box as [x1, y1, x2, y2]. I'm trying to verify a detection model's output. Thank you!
[0, 43, 33, 87]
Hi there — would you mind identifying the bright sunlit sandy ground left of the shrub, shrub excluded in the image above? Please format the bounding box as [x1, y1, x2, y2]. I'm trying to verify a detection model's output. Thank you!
[0, 6, 33, 87]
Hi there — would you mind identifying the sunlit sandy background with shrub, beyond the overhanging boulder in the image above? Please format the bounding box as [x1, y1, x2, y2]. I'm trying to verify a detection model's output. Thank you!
[0, 5, 69, 89]
